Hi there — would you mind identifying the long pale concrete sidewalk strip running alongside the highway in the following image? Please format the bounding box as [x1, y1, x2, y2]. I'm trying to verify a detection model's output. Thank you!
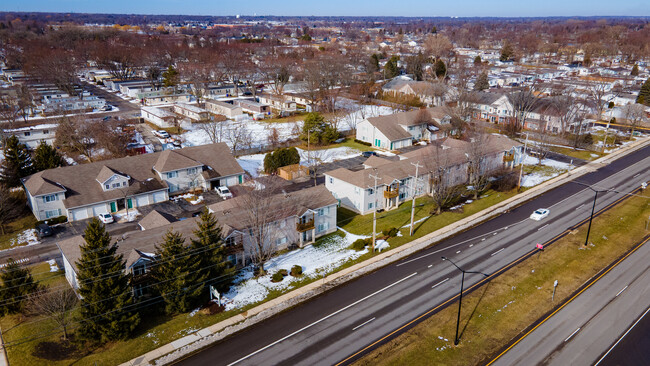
[120, 138, 650, 366]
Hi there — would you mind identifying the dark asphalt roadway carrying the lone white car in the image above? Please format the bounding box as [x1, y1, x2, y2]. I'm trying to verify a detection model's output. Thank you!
[175, 142, 650, 365]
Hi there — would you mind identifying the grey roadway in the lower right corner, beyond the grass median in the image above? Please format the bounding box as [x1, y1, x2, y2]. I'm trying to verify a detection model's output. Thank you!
[492, 236, 650, 366]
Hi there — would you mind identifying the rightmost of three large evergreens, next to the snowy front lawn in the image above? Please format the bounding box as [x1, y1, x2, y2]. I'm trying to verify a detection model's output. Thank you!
[190, 210, 235, 298]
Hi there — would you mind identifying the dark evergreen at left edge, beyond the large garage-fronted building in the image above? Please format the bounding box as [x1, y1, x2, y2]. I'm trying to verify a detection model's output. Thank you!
[0, 135, 33, 188]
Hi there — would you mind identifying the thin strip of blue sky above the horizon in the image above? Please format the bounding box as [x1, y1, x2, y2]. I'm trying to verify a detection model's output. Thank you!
[0, 0, 650, 17]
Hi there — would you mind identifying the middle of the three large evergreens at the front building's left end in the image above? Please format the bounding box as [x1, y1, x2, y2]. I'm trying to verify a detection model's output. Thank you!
[151, 230, 201, 314]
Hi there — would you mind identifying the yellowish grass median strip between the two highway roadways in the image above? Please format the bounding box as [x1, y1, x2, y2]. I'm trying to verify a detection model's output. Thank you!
[358, 193, 650, 365]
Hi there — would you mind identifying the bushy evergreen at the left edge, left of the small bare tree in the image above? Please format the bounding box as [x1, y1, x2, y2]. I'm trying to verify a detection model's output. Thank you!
[0, 258, 38, 314]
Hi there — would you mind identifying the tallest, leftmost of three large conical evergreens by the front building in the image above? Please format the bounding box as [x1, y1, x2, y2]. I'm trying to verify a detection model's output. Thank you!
[77, 218, 140, 342]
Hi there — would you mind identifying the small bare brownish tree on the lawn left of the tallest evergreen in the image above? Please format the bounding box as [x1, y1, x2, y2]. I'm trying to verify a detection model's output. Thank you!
[27, 288, 78, 339]
